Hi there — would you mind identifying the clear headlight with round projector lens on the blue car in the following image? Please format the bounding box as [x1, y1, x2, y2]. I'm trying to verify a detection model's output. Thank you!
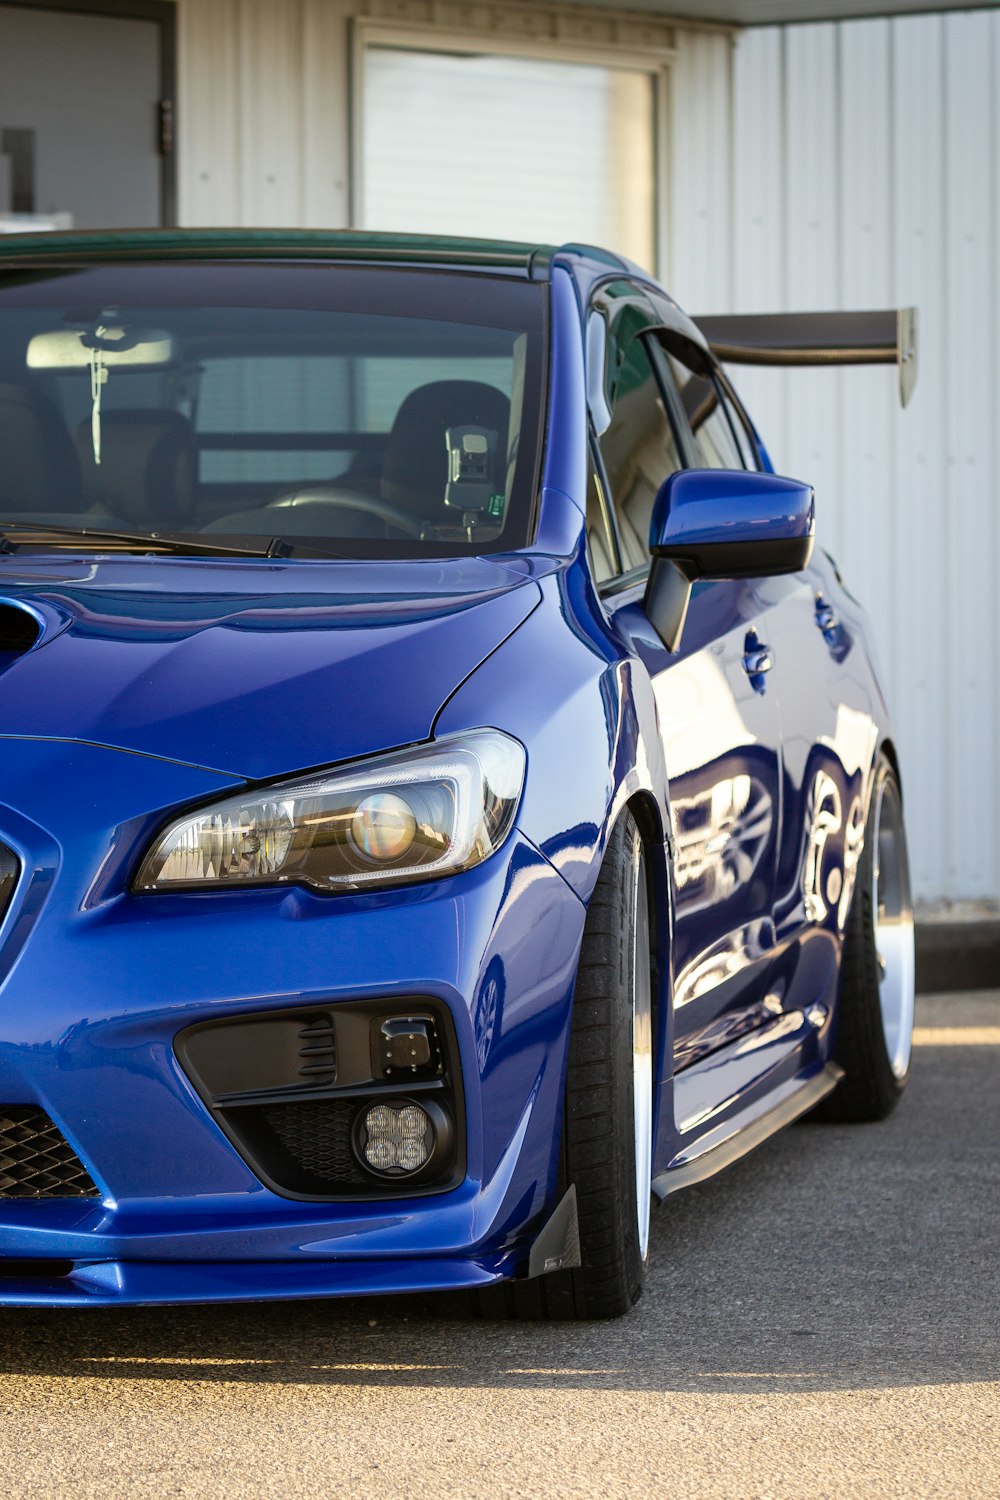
[135, 729, 525, 891]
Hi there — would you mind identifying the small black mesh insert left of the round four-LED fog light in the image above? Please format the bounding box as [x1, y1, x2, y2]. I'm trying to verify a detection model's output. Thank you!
[226, 1100, 372, 1197]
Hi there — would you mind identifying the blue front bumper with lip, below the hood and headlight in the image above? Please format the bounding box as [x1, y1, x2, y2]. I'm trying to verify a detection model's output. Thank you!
[0, 740, 585, 1304]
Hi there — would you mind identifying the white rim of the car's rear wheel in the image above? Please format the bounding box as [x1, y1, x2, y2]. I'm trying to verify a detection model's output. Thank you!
[871, 780, 915, 1079]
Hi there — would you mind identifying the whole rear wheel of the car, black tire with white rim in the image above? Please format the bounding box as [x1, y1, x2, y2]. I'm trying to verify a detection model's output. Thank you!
[817, 756, 915, 1121]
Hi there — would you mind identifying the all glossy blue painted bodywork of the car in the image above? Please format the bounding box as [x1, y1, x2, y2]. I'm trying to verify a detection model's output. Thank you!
[0, 236, 889, 1305]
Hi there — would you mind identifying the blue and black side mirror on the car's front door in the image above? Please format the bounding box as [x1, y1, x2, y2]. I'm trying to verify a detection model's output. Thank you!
[645, 470, 816, 651]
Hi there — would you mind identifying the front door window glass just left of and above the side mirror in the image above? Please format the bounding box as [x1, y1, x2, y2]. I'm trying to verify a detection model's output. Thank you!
[600, 338, 682, 572]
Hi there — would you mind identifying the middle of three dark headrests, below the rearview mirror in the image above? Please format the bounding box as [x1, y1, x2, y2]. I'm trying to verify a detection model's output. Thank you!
[76, 408, 198, 524]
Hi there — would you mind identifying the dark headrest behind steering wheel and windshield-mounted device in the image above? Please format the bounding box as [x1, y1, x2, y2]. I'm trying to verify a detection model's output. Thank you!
[379, 380, 510, 519]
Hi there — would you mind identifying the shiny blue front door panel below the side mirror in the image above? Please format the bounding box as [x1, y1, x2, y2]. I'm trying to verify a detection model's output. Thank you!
[616, 582, 780, 1070]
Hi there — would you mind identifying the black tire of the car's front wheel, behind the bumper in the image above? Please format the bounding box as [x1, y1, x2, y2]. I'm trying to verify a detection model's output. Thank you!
[478, 813, 655, 1319]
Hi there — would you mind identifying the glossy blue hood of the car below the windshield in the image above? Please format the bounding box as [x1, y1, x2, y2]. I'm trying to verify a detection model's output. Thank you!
[0, 555, 540, 779]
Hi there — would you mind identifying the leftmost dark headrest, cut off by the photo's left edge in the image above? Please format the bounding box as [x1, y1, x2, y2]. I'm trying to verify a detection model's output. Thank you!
[0, 383, 84, 516]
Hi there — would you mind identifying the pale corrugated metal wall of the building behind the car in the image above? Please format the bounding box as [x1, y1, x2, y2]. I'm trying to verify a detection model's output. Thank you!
[178, 0, 1000, 899]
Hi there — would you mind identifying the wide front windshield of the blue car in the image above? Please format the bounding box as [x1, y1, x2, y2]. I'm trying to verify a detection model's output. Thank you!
[0, 263, 546, 557]
